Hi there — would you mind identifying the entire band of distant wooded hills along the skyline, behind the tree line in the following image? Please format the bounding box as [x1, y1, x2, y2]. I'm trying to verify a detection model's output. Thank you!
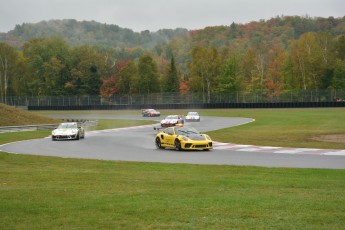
[0, 16, 345, 51]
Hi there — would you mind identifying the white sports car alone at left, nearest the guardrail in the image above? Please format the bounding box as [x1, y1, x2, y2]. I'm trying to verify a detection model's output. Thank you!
[52, 122, 85, 141]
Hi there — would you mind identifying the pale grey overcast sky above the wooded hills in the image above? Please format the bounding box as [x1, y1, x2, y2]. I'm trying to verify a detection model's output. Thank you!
[0, 0, 345, 32]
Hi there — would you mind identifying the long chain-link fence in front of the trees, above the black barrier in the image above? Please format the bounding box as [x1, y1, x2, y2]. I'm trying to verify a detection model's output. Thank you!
[0, 90, 345, 106]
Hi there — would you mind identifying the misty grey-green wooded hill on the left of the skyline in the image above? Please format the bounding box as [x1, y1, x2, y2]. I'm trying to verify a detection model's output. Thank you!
[0, 19, 188, 49]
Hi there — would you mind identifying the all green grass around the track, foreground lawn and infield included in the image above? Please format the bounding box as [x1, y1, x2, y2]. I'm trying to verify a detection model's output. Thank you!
[0, 109, 345, 230]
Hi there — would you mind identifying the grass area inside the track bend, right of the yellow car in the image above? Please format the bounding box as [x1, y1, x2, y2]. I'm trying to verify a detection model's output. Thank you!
[204, 108, 345, 149]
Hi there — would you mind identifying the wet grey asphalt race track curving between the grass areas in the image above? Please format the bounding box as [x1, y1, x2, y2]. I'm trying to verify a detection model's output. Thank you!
[0, 115, 345, 169]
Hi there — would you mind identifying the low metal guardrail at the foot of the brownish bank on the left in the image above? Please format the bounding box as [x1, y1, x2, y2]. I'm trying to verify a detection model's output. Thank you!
[0, 119, 97, 133]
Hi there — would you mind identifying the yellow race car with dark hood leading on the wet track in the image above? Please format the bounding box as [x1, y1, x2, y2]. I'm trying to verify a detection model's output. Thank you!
[155, 126, 212, 150]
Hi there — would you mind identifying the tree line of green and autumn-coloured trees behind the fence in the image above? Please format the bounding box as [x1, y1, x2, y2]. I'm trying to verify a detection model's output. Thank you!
[0, 16, 345, 101]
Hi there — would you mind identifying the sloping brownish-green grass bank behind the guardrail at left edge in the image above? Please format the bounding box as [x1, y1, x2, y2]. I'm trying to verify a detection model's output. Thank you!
[0, 103, 60, 126]
